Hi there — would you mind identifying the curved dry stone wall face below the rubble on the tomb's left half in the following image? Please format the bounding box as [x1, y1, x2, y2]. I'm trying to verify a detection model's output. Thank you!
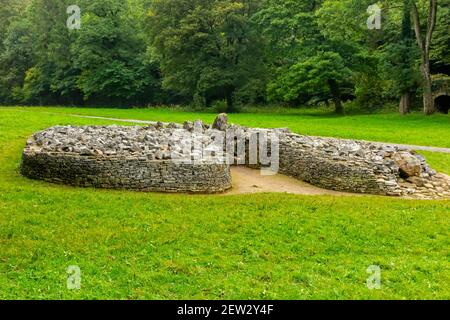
[21, 152, 231, 193]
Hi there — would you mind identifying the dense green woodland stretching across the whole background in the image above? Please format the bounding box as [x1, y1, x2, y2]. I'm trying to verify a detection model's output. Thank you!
[0, 0, 450, 114]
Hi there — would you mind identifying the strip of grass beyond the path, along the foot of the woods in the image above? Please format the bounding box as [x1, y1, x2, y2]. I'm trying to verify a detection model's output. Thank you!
[4, 108, 450, 148]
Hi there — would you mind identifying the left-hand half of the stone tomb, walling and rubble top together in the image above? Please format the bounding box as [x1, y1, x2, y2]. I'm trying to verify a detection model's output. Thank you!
[21, 126, 231, 193]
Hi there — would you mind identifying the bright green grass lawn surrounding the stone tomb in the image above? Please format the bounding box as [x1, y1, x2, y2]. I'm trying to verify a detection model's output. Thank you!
[0, 108, 450, 299]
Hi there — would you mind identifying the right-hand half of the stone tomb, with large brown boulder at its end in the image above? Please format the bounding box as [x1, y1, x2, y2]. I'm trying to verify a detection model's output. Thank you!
[228, 126, 450, 199]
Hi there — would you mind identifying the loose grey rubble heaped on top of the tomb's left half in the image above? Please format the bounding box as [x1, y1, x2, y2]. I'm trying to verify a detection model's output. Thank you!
[27, 121, 223, 160]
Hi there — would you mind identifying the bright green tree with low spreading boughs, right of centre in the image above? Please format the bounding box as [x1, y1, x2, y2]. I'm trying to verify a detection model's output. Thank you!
[255, 0, 371, 114]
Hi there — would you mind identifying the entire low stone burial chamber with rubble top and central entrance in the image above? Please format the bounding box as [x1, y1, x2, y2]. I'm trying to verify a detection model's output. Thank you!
[21, 114, 450, 199]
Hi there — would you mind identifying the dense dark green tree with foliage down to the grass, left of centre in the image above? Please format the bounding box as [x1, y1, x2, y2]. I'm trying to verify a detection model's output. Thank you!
[71, 0, 158, 104]
